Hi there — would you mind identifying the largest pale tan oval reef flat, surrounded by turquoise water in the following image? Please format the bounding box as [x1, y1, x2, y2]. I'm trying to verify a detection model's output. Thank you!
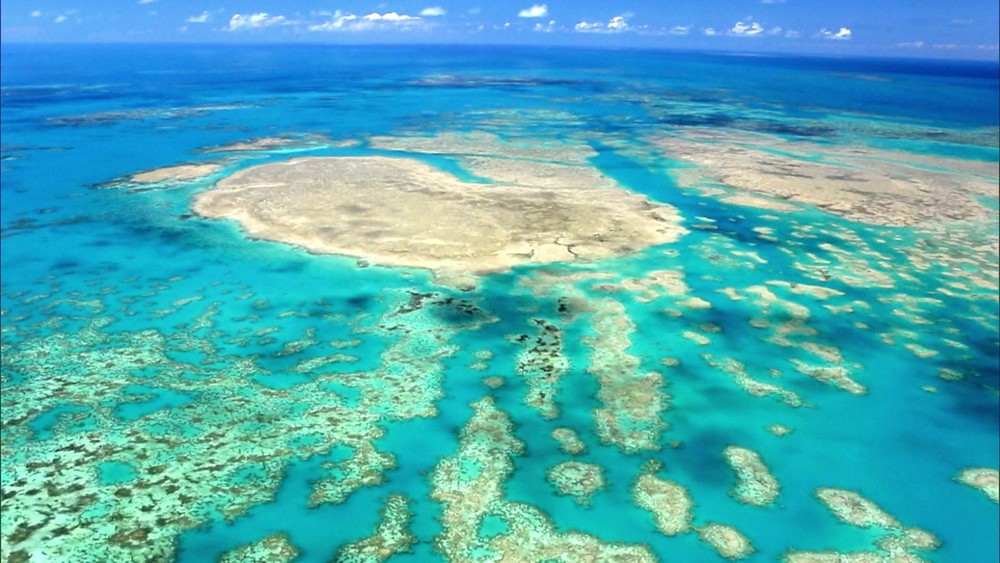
[194, 157, 686, 274]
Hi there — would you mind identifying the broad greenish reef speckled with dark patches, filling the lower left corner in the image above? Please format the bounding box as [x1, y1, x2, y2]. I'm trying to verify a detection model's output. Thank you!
[0, 286, 492, 561]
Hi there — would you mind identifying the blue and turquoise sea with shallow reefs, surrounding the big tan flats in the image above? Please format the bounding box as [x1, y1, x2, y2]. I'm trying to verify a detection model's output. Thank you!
[0, 46, 1000, 562]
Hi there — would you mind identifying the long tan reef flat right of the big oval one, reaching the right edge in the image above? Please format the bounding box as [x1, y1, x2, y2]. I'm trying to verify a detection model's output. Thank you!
[654, 128, 1000, 226]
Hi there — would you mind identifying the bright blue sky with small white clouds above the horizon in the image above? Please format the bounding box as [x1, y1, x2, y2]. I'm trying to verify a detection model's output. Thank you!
[0, 0, 1000, 60]
